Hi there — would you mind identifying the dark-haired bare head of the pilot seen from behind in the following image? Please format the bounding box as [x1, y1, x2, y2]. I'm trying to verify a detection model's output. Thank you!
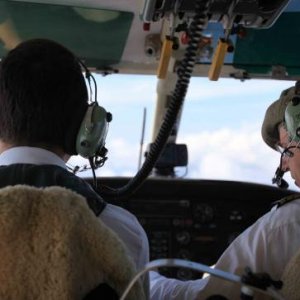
[0, 39, 88, 155]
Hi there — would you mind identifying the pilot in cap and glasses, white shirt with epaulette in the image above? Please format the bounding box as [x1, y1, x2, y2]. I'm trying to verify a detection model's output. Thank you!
[150, 83, 300, 300]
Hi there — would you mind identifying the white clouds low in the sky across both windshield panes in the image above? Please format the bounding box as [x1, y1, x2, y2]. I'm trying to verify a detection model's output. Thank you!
[72, 126, 297, 189]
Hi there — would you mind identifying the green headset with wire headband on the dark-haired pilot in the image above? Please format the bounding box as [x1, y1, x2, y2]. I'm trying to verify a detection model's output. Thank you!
[76, 60, 112, 162]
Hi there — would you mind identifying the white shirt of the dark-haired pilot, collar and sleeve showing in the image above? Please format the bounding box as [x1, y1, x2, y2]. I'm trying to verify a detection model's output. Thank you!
[0, 147, 149, 270]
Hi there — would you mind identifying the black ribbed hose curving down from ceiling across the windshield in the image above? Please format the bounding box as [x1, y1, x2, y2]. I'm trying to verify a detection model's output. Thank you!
[99, 0, 210, 199]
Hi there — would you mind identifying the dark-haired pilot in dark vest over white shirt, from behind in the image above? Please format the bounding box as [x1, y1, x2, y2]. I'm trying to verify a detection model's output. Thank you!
[0, 39, 149, 296]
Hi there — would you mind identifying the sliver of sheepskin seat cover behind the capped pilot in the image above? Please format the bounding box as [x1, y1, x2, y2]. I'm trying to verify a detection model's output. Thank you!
[282, 246, 300, 300]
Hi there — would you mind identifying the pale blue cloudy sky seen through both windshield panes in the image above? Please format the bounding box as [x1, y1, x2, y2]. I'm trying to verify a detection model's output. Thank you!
[70, 75, 296, 189]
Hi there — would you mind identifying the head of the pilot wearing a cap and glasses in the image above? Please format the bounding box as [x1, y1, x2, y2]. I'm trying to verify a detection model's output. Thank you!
[261, 82, 300, 186]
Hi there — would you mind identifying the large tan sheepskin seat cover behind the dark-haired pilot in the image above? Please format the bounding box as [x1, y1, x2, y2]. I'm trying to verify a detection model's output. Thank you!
[0, 185, 144, 300]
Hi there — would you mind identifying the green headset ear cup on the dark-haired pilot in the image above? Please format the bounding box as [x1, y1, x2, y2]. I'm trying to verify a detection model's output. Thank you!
[76, 103, 111, 158]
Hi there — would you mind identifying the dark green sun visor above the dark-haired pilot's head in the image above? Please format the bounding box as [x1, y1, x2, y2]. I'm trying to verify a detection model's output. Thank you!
[0, 0, 133, 69]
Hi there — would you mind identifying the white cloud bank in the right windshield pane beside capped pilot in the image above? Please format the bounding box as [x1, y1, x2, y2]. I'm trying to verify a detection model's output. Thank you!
[178, 126, 296, 188]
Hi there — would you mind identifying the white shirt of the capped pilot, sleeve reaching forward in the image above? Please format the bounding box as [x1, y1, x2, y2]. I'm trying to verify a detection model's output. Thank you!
[150, 199, 300, 300]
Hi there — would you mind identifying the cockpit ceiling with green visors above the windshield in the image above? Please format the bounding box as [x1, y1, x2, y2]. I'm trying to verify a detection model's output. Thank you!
[0, 0, 300, 79]
